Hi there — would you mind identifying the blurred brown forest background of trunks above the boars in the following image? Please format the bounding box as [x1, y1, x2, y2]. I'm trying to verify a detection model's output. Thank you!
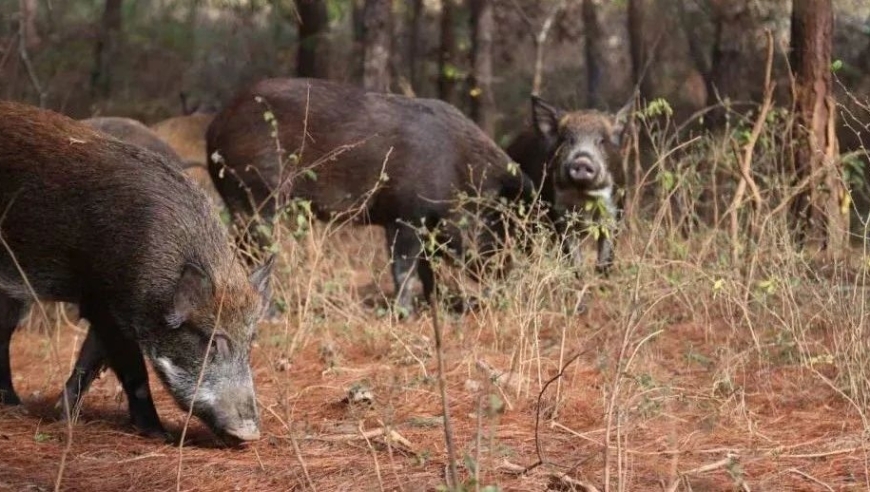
[0, 0, 870, 144]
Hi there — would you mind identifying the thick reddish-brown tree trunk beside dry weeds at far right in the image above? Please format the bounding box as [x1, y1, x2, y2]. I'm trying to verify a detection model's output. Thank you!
[791, 0, 849, 254]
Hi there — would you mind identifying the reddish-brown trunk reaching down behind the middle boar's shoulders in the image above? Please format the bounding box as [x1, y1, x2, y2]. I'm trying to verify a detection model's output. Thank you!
[469, 0, 495, 137]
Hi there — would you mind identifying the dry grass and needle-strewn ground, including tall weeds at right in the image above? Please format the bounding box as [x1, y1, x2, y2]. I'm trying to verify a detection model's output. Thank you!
[0, 94, 870, 491]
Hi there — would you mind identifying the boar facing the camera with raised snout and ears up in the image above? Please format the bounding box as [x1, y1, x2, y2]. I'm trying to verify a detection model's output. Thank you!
[507, 96, 632, 273]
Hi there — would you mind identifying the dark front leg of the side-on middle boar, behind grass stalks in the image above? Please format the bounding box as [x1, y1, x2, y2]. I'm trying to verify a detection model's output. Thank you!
[386, 223, 435, 314]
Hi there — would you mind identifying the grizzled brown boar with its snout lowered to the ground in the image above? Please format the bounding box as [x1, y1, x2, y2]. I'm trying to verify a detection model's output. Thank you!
[0, 102, 271, 441]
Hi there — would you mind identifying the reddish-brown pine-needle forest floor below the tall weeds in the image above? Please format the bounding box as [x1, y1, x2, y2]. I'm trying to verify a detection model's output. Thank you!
[0, 224, 870, 492]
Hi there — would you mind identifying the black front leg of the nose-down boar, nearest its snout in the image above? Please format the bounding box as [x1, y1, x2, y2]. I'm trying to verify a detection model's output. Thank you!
[81, 303, 165, 435]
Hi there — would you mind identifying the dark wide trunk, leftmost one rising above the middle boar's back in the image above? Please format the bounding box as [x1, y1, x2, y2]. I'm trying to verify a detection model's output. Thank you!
[296, 0, 329, 78]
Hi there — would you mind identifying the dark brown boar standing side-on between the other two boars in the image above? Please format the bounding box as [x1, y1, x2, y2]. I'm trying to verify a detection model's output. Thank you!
[206, 79, 533, 312]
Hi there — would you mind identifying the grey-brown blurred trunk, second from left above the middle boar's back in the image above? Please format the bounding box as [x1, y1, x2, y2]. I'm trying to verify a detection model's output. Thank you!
[363, 0, 393, 92]
